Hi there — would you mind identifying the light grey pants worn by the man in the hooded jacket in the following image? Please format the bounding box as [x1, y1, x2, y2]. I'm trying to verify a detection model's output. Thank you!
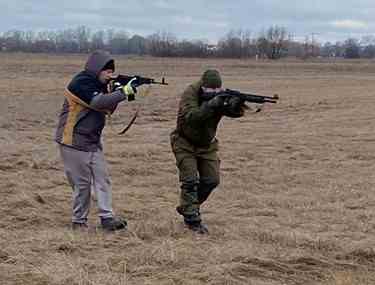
[59, 145, 113, 223]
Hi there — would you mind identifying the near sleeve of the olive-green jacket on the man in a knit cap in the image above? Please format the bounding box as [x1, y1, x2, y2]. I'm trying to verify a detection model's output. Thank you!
[180, 86, 215, 124]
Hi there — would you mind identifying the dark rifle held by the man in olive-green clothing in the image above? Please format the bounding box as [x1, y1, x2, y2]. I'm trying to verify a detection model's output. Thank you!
[204, 89, 279, 104]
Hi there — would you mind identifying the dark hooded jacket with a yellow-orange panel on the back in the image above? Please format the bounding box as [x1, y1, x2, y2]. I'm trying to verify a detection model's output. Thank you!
[55, 51, 126, 151]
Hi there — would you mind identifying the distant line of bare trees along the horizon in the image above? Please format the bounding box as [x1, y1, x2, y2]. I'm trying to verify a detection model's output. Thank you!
[0, 26, 375, 59]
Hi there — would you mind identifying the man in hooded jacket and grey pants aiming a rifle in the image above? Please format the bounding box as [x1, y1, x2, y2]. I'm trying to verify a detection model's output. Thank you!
[55, 51, 136, 231]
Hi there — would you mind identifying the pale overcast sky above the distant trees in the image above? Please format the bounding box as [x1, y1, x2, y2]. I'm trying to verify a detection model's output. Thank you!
[0, 0, 375, 42]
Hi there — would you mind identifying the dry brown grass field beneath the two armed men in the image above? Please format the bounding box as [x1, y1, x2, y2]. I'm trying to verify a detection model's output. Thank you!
[0, 53, 375, 285]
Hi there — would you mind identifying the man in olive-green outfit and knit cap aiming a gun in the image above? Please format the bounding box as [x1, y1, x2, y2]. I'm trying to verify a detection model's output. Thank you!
[171, 70, 245, 234]
